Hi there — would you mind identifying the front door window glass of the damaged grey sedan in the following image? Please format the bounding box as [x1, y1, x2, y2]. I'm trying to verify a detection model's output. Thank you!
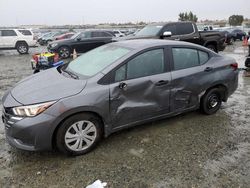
[115, 49, 164, 81]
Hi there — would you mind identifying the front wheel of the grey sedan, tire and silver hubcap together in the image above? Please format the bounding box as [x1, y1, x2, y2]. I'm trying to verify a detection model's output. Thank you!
[55, 113, 103, 156]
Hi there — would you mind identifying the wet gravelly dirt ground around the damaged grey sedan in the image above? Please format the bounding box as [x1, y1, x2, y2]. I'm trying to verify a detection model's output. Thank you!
[0, 43, 250, 188]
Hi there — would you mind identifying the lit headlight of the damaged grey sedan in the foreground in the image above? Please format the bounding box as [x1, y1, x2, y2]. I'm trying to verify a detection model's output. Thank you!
[12, 101, 56, 117]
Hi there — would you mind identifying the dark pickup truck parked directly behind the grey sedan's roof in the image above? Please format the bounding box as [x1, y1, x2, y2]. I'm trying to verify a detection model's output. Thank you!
[114, 22, 226, 52]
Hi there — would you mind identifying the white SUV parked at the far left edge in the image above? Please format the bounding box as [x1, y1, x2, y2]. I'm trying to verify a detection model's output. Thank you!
[0, 29, 36, 54]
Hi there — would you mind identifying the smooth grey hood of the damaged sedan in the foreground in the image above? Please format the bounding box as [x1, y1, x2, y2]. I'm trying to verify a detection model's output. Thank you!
[11, 68, 86, 105]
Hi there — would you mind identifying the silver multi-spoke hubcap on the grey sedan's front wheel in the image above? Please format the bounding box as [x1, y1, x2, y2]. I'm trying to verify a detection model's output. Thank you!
[64, 120, 97, 151]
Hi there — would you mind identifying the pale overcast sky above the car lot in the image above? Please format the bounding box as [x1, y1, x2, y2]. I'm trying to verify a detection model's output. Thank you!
[0, 0, 250, 26]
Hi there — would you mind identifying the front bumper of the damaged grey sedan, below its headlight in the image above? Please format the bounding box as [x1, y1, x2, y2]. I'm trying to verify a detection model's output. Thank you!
[2, 109, 55, 151]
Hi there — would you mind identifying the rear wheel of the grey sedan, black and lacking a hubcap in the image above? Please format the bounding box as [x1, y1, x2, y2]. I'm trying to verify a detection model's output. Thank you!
[200, 88, 222, 115]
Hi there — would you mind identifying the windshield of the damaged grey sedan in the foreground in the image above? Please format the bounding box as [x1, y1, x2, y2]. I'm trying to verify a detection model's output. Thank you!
[67, 45, 131, 77]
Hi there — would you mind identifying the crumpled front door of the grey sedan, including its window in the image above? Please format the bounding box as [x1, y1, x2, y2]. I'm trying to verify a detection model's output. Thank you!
[110, 48, 171, 128]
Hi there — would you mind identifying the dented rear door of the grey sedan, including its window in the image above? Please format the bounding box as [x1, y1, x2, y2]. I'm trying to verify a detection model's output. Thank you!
[171, 47, 213, 112]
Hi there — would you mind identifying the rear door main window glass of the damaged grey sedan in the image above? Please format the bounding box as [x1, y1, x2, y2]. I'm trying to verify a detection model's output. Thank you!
[172, 48, 199, 70]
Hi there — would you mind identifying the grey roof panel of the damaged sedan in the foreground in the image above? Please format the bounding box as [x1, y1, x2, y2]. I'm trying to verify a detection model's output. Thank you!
[111, 39, 206, 49]
